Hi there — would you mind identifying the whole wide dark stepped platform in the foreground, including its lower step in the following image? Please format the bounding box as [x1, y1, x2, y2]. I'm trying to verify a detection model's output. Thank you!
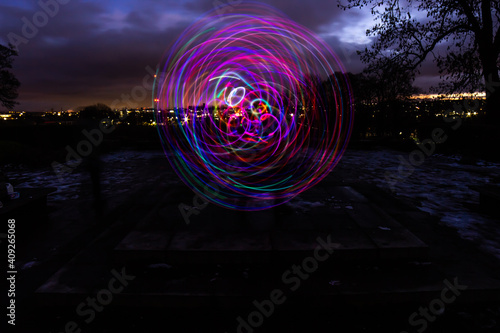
[36, 182, 500, 308]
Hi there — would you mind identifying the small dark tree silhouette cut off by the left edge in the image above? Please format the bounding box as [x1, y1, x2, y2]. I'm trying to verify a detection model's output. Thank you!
[0, 44, 20, 109]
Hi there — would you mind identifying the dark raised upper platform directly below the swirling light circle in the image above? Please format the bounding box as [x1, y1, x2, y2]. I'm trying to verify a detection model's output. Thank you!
[114, 187, 428, 264]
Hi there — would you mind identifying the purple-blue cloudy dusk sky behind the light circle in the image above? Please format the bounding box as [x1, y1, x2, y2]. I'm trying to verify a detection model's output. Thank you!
[0, 0, 434, 111]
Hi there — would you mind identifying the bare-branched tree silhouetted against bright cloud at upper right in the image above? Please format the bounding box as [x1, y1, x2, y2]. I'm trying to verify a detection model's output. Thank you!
[339, 0, 500, 121]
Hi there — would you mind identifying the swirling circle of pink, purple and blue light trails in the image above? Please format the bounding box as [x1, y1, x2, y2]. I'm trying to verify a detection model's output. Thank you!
[154, 3, 353, 210]
